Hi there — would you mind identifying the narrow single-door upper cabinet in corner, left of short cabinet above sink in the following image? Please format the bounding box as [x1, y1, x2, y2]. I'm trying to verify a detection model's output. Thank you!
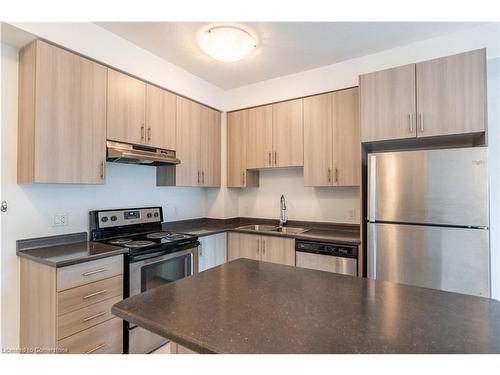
[227, 110, 259, 187]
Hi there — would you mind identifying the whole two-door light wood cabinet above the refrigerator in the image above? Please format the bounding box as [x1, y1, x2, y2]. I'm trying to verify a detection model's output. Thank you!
[359, 49, 487, 142]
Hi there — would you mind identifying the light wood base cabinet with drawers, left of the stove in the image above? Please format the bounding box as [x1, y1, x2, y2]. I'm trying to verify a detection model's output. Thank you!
[20, 255, 123, 353]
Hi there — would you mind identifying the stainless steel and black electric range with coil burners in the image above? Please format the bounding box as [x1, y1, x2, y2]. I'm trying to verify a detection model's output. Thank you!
[90, 207, 200, 354]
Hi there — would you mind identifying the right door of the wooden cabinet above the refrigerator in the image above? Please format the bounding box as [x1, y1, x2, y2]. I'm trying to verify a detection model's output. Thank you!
[417, 49, 487, 137]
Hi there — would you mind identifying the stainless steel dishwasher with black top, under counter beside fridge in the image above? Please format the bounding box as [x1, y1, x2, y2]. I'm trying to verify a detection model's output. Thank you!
[295, 240, 358, 276]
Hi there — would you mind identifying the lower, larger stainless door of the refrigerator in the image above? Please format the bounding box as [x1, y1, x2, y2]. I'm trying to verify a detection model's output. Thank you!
[368, 223, 490, 297]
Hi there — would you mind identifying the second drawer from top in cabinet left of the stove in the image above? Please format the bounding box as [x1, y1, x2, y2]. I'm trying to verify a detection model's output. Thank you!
[57, 275, 123, 315]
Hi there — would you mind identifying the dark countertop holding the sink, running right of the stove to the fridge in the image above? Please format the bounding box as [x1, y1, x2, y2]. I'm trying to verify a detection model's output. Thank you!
[163, 218, 361, 245]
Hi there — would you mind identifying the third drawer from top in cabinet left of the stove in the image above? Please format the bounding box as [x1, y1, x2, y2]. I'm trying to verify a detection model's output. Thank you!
[57, 296, 122, 340]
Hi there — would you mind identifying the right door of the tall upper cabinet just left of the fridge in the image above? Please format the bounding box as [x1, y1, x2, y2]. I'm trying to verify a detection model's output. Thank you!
[332, 87, 361, 186]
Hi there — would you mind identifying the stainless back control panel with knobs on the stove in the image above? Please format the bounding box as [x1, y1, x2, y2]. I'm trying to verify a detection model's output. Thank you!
[97, 207, 162, 228]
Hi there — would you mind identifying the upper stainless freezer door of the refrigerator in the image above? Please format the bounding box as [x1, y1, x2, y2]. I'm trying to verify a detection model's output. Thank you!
[368, 147, 489, 227]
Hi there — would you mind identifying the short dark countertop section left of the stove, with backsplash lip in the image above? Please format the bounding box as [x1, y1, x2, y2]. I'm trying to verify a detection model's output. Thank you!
[17, 232, 129, 267]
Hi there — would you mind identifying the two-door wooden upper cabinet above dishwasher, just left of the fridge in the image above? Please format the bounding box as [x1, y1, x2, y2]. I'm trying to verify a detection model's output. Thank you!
[304, 88, 361, 186]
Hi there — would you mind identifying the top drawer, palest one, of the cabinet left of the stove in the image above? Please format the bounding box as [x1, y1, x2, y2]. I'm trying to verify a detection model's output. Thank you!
[57, 255, 123, 291]
